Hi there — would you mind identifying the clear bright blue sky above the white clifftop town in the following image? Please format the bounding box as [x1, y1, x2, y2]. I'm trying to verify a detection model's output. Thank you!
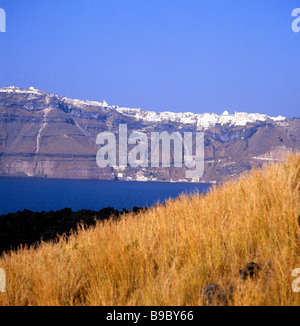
[0, 0, 300, 118]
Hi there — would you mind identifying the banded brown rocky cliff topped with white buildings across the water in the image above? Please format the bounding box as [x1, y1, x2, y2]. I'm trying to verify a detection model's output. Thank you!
[0, 87, 300, 182]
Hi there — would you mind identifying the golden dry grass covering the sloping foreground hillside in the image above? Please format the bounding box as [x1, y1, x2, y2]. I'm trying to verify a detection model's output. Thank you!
[0, 154, 300, 305]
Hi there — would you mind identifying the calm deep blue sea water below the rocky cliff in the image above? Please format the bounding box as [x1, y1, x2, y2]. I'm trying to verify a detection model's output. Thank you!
[0, 178, 210, 215]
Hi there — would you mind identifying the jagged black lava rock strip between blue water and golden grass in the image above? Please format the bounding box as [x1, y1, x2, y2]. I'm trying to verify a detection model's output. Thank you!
[0, 207, 146, 254]
